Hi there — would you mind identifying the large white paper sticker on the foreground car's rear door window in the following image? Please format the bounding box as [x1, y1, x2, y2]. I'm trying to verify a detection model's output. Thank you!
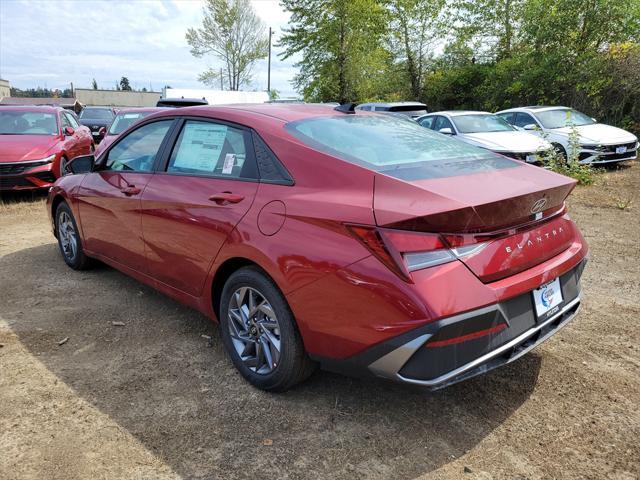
[173, 123, 228, 172]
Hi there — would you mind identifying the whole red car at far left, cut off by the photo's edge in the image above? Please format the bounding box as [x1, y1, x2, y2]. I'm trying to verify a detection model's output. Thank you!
[0, 106, 94, 191]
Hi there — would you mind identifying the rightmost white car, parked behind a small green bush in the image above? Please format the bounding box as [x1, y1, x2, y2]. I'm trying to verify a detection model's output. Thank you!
[496, 106, 638, 165]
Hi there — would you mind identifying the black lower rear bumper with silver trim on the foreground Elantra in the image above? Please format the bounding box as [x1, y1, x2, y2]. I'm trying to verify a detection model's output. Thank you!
[319, 259, 586, 390]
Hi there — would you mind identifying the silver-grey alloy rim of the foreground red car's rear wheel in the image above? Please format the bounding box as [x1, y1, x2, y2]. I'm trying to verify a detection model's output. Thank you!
[228, 287, 281, 375]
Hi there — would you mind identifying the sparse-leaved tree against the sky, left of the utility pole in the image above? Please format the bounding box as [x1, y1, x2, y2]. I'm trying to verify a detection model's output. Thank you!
[186, 0, 269, 90]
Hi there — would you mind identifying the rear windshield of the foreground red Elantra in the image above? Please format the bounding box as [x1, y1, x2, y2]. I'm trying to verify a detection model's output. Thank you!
[286, 114, 518, 181]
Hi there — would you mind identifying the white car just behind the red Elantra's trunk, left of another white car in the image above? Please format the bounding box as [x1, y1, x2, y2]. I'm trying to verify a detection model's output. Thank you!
[416, 111, 553, 163]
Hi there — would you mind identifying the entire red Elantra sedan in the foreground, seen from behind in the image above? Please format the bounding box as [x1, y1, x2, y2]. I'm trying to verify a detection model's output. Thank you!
[47, 105, 587, 391]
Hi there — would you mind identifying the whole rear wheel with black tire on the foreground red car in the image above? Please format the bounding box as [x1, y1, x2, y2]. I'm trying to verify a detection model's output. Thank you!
[218, 267, 316, 392]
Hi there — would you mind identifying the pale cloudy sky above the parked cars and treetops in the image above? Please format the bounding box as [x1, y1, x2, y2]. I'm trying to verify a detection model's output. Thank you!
[0, 0, 297, 97]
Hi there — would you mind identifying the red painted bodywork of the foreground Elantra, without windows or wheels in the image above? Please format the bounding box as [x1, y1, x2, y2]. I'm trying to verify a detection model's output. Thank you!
[48, 105, 587, 368]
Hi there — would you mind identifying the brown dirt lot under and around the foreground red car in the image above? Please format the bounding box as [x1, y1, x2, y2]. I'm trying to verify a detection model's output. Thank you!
[0, 165, 640, 480]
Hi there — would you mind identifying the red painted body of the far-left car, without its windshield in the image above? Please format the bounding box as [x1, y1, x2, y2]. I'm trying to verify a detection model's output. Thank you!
[0, 106, 93, 190]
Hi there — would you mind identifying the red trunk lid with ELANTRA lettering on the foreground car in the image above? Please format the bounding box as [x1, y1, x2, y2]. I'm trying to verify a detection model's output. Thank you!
[374, 165, 576, 282]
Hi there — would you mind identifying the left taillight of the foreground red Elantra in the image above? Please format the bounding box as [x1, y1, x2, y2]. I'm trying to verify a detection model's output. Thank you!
[347, 225, 482, 281]
